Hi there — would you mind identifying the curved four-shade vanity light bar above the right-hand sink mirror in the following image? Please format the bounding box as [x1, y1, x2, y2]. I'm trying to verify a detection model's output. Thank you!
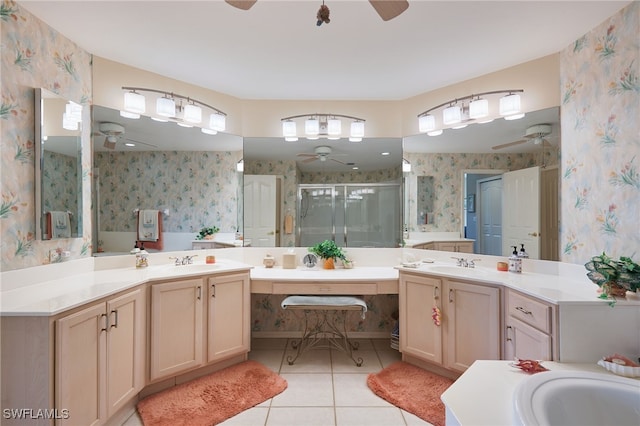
[418, 89, 524, 136]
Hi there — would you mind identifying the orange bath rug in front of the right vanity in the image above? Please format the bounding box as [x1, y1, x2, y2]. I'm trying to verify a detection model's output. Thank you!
[367, 361, 453, 426]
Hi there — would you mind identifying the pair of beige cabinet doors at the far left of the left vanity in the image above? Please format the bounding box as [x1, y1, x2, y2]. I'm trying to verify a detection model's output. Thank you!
[55, 288, 145, 425]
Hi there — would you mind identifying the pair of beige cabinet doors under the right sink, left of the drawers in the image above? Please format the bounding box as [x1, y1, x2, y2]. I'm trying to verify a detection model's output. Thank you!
[399, 271, 501, 372]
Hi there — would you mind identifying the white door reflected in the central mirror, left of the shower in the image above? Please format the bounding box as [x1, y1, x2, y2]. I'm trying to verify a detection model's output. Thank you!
[244, 175, 276, 247]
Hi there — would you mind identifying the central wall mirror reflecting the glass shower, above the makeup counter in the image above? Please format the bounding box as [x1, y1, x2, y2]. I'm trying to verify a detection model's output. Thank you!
[244, 138, 402, 247]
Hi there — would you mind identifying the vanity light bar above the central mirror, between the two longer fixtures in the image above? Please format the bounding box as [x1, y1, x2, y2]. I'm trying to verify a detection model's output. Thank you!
[280, 113, 365, 142]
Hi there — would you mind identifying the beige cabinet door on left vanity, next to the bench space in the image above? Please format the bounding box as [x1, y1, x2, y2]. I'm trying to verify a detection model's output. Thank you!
[207, 274, 251, 362]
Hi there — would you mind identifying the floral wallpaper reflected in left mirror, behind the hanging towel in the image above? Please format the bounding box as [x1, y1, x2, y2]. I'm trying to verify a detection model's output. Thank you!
[94, 151, 242, 233]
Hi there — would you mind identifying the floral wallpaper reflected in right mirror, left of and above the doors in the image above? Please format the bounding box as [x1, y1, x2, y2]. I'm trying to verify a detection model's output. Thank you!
[403, 150, 558, 232]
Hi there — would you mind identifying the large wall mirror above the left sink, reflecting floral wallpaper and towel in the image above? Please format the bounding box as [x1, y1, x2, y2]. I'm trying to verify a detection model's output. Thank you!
[92, 106, 243, 253]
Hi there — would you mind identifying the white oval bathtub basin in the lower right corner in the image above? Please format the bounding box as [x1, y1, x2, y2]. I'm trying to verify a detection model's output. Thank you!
[513, 371, 640, 426]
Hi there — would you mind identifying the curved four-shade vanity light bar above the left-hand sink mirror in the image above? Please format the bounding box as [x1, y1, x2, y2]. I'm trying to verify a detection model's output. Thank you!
[121, 86, 227, 135]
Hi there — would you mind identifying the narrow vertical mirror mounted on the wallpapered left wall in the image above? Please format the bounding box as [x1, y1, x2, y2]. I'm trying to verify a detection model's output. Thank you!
[35, 89, 82, 240]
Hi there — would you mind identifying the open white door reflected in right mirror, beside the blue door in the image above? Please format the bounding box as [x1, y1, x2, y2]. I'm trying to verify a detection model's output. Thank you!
[502, 167, 540, 259]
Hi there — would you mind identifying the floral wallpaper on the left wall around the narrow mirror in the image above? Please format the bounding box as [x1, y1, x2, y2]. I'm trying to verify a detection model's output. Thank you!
[0, 0, 92, 271]
